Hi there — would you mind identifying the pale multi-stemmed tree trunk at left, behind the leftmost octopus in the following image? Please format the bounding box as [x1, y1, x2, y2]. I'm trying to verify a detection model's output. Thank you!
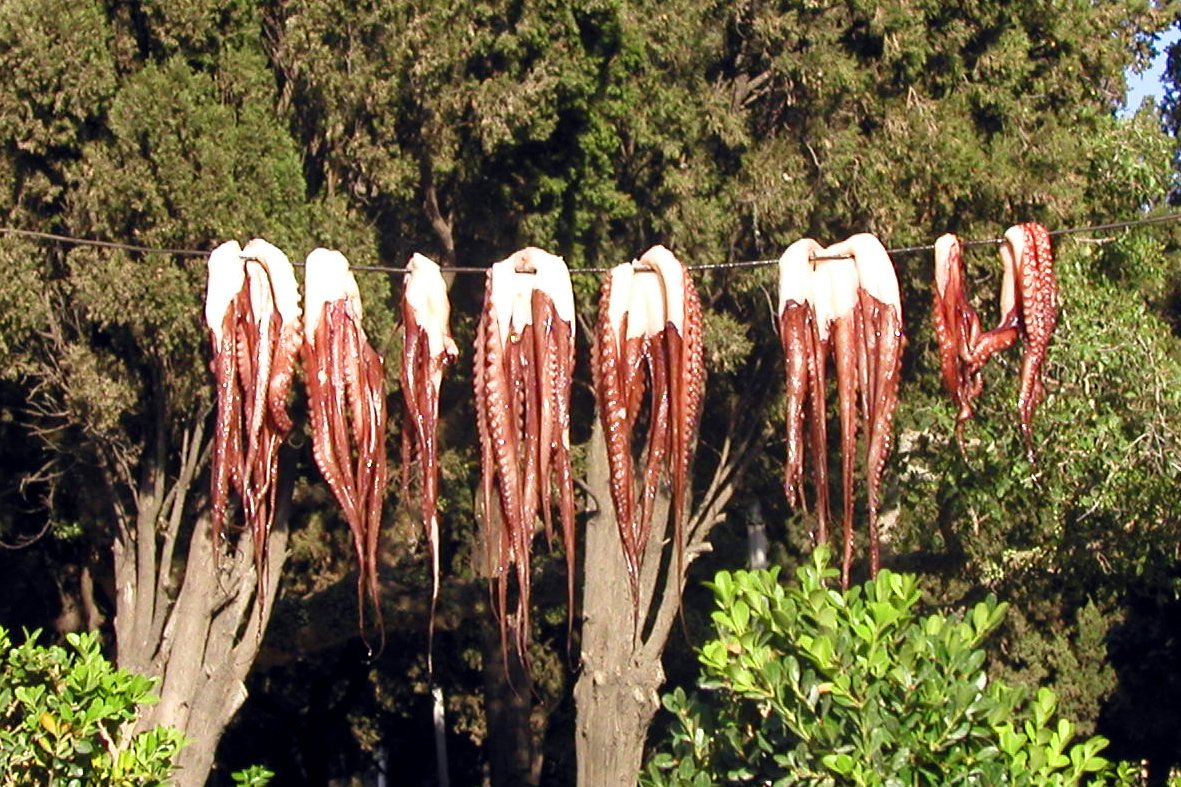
[113, 413, 294, 787]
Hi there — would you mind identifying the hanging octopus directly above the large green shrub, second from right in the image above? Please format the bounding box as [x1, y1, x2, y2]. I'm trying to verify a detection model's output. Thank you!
[778, 234, 903, 587]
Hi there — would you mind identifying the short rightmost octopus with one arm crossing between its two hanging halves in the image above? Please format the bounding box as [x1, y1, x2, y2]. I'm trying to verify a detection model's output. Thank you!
[935, 222, 1058, 462]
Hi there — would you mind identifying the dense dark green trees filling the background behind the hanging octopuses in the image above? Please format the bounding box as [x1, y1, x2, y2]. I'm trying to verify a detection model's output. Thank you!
[0, 0, 1181, 785]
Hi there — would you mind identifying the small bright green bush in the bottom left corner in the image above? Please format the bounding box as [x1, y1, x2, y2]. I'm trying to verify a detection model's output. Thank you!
[0, 629, 184, 787]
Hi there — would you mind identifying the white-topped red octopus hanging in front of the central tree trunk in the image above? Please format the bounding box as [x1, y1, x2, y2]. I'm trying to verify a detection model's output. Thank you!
[592, 246, 705, 610]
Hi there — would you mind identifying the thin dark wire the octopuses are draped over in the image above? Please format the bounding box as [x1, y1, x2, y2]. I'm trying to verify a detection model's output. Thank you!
[0, 213, 1181, 274]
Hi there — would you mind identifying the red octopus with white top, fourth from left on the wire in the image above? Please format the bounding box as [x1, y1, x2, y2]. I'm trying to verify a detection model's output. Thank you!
[475, 248, 575, 658]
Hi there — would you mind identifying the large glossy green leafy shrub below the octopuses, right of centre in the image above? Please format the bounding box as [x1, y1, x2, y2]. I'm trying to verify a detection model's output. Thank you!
[641, 547, 1135, 787]
